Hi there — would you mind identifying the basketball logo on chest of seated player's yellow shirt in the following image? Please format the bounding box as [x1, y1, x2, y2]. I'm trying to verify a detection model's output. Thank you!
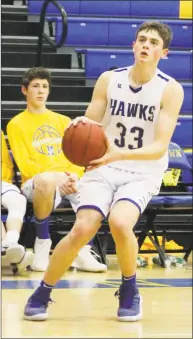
[32, 125, 62, 156]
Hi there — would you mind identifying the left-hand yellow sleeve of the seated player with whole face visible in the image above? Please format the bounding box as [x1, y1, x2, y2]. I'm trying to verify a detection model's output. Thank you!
[7, 122, 44, 178]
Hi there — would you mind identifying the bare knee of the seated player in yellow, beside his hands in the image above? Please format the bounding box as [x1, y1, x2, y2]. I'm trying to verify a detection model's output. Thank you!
[34, 173, 56, 197]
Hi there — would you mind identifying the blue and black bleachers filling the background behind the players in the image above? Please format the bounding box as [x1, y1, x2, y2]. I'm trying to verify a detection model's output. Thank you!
[2, 0, 192, 266]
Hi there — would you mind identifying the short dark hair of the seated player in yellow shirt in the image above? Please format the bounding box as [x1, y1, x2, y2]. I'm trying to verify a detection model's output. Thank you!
[22, 67, 51, 89]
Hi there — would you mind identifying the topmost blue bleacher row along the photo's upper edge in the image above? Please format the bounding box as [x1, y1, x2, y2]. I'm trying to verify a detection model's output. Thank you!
[28, 0, 188, 19]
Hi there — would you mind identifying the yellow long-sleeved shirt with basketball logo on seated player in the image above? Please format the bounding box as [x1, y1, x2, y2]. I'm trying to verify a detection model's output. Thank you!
[7, 109, 84, 183]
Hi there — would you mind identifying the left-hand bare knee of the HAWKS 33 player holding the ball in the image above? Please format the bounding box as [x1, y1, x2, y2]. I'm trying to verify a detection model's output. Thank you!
[71, 209, 102, 242]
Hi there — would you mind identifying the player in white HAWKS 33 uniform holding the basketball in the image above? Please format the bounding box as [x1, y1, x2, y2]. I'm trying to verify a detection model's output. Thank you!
[24, 22, 184, 321]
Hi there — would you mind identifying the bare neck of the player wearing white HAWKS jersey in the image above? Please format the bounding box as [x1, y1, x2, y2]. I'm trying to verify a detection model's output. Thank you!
[129, 64, 157, 86]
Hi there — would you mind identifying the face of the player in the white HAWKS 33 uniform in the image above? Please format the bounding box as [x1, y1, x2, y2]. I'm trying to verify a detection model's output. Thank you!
[133, 30, 168, 64]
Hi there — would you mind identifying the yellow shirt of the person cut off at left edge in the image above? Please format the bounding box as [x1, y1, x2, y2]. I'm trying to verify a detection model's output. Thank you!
[1, 131, 13, 183]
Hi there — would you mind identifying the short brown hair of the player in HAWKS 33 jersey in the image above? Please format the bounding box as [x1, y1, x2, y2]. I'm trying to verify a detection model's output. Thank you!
[136, 21, 173, 48]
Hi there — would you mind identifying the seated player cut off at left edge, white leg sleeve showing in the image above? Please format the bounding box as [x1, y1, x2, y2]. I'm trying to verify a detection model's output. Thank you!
[1, 131, 33, 271]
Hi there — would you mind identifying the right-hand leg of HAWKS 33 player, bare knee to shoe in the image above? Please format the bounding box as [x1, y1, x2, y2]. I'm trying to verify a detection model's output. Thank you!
[109, 201, 141, 321]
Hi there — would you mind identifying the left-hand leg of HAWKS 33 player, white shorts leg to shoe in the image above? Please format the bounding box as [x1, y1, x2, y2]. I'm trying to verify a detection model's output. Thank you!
[24, 171, 113, 320]
